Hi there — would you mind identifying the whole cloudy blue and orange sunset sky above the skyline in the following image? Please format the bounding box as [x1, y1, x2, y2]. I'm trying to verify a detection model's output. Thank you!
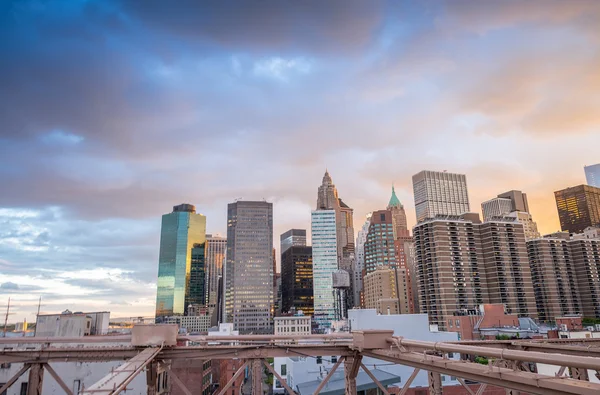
[0, 0, 600, 322]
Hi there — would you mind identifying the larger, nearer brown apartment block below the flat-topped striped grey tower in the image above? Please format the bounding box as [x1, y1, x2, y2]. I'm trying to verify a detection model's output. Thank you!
[414, 213, 537, 330]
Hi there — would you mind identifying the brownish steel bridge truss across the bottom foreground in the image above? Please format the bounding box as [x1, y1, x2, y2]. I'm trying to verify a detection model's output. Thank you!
[0, 330, 600, 395]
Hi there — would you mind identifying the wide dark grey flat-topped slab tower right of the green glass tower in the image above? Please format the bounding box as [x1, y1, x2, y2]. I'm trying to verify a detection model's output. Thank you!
[225, 201, 273, 334]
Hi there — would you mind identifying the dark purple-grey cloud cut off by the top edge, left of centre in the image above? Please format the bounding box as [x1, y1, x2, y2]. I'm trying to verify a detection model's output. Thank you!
[123, 0, 385, 56]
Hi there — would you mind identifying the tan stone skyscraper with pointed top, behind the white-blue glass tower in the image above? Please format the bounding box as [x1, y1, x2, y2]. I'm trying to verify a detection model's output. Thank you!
[317, 171, 356, 308]
